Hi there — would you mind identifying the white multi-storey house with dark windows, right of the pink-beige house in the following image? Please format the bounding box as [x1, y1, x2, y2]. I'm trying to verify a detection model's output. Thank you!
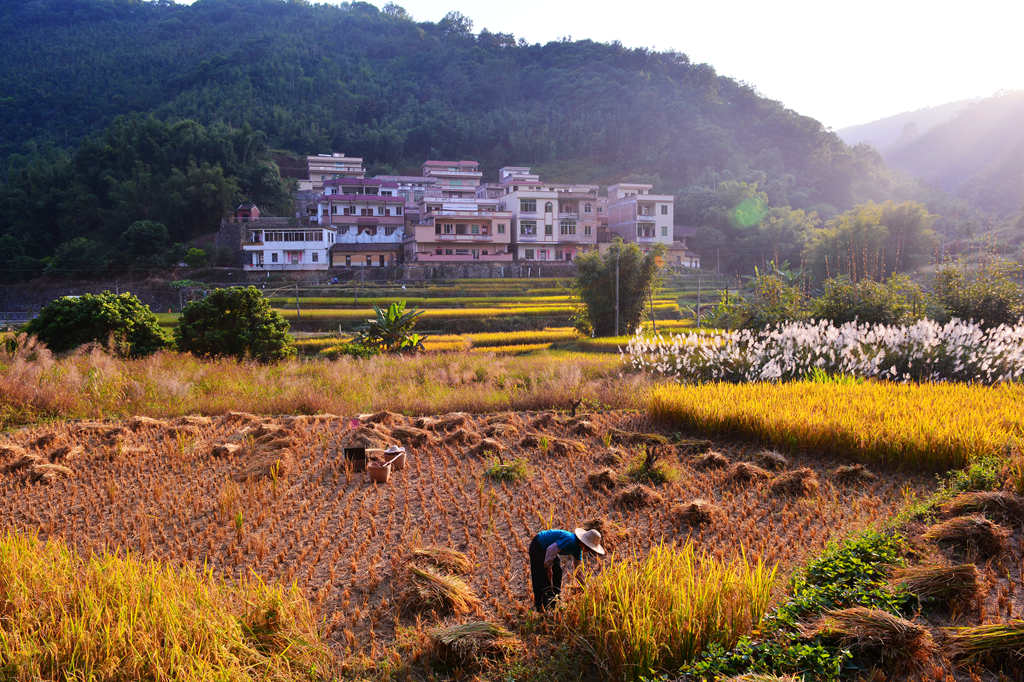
[498, 166, 600, 262]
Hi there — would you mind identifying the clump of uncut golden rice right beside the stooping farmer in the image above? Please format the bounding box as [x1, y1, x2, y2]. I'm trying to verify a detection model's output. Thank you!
[561, 542, 776, 679]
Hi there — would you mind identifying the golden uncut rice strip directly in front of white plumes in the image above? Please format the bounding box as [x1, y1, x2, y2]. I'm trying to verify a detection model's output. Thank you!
[649, 381, 1024, 471]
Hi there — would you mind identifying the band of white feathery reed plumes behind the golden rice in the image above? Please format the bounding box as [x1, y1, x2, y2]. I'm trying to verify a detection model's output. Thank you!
[628, 319, 1024, 384]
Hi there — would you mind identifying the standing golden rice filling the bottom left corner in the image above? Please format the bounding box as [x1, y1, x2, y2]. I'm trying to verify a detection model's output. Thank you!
[0, 534, 333, 682]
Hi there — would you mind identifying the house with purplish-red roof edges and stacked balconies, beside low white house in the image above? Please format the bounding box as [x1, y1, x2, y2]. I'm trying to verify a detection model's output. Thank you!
[315, 177, 406, 267]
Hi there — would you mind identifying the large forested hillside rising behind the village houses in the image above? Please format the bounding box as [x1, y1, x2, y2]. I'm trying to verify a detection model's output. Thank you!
[0, 0, 925, 276]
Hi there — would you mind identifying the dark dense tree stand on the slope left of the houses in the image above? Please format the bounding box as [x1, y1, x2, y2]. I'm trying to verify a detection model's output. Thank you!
[0, 116, 291, 280]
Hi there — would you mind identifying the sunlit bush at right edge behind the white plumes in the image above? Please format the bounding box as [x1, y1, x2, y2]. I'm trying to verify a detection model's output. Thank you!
[933, 260, 1024, 327]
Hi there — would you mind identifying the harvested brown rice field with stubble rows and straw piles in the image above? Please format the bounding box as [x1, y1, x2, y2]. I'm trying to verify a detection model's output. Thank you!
[0, 412, 937, 656]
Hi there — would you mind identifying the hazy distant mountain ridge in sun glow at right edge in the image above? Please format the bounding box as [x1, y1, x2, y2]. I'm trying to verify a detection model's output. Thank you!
[838, 91, 1024, 215]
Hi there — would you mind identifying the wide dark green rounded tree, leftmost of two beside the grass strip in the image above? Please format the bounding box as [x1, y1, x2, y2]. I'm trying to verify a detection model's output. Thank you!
[25, 291, 170, 356]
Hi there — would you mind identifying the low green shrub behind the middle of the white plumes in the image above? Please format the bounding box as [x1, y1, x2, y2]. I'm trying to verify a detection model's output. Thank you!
[811, 274, 925, 325]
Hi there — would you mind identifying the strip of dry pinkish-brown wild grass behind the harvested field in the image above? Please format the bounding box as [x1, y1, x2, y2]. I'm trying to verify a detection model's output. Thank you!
[0, 339, 638, 428]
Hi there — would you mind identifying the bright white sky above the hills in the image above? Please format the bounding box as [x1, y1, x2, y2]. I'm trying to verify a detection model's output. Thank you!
[169, 0, 1024, 130]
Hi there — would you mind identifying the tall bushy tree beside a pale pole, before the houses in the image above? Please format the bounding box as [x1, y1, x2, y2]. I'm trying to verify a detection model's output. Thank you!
[575, 239, 664, 336]
